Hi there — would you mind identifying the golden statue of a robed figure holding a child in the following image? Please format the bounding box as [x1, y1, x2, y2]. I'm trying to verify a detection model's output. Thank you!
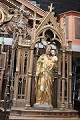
[35, 45, 58, 108]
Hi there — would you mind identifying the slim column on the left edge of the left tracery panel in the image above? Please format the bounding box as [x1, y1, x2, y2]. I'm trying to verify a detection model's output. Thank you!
[13, 48, 20, 101]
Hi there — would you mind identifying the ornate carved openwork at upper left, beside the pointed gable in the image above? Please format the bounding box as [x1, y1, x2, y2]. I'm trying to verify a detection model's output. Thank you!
[0, 6, 31, 45]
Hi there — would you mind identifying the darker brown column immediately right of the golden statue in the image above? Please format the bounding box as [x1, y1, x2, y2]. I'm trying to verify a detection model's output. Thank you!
[57, 52, 62, 108]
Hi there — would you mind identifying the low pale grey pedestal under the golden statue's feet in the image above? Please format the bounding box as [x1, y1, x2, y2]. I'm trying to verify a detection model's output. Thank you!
[33, 103, 53, 110]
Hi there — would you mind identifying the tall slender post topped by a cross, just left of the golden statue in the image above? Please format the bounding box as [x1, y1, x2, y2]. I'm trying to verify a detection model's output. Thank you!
[26, 11, 36, 108]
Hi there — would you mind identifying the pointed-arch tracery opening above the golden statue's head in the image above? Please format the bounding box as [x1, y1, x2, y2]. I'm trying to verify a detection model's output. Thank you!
[35, 29, 61, 55]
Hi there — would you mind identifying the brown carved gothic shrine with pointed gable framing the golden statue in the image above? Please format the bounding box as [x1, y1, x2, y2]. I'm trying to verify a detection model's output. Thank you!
[0, 0, 77, 120]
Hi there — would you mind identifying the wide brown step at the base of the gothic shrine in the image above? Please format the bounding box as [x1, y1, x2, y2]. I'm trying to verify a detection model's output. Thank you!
[9, 108, 80, 120]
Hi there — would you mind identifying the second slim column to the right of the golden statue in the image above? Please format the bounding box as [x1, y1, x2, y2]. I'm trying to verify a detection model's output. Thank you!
[61, 49, 65, 108]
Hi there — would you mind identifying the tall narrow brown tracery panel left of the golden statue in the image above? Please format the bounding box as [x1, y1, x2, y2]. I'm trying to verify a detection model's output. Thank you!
[18, 50, 28, 99]
